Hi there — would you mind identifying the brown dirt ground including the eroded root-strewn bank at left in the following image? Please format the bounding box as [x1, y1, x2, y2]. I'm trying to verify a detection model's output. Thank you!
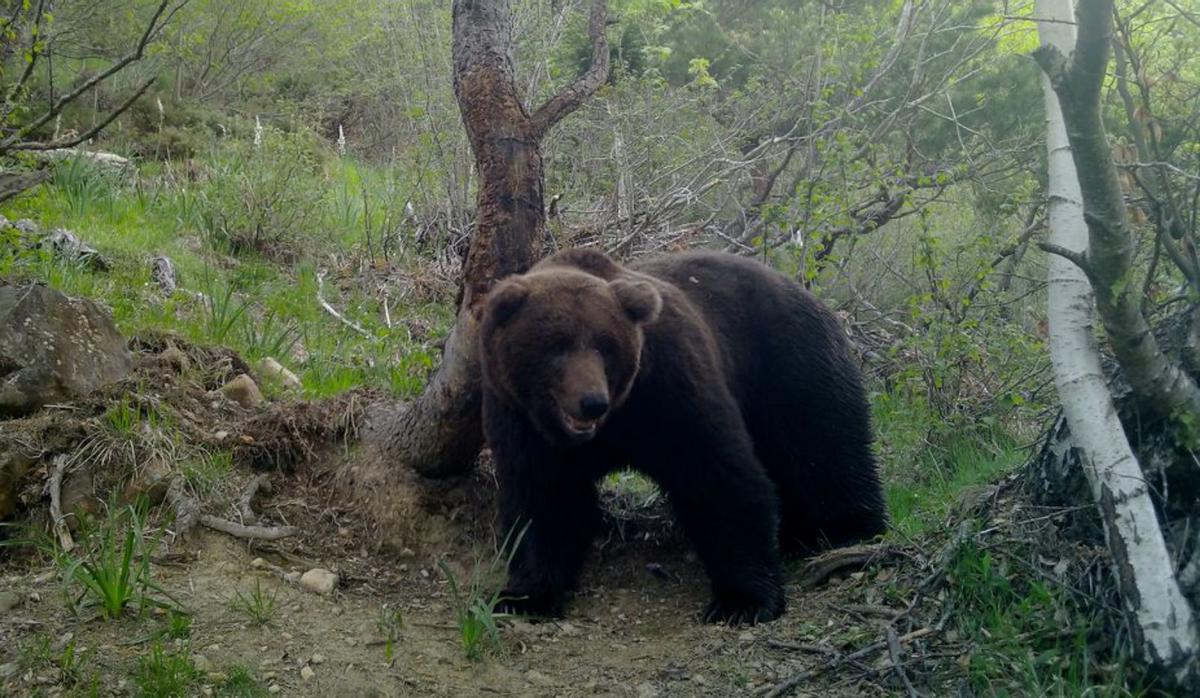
[0, 338, 988, 697]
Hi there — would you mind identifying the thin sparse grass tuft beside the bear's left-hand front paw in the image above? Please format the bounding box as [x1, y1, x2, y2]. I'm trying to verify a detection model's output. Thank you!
[438, 524, 528, 661]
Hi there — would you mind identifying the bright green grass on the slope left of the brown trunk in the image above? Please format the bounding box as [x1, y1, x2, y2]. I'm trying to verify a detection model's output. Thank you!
[0, 140, 454, 398]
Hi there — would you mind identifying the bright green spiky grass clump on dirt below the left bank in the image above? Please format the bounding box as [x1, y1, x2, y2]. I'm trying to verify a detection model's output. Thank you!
[50, 503, 177, 620]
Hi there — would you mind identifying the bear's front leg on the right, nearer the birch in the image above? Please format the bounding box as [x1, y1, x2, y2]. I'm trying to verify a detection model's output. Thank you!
[637, 401, 785, 625]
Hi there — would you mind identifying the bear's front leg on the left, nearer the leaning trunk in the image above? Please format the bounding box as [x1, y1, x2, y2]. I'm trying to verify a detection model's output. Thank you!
[484, 397, 600, 616]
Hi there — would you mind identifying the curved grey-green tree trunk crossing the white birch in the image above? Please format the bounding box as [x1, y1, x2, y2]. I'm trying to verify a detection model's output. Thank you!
[1033, 0, 1200, 417]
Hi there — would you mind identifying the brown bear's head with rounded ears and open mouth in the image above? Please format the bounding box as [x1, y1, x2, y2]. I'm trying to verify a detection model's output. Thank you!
[476, 266, 662, 445]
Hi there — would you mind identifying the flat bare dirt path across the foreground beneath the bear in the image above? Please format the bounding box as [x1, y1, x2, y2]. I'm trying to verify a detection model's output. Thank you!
[0, 518, 902, 697]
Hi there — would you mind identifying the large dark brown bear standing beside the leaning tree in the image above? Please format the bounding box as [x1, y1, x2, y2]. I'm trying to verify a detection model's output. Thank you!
[476, 249, 886, 624]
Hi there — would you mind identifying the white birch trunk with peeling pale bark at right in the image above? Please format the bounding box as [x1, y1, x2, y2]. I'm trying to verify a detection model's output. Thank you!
[1037, 0, 1198, 687]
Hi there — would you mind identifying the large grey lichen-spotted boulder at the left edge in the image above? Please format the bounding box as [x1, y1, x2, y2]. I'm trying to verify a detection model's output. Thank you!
[0, 285, 133, 419]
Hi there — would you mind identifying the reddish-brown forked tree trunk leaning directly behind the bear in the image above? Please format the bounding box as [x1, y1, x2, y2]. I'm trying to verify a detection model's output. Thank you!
[385, 0, 608, 477]
